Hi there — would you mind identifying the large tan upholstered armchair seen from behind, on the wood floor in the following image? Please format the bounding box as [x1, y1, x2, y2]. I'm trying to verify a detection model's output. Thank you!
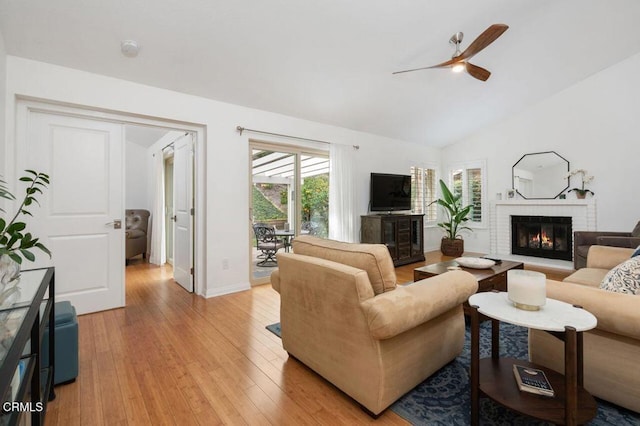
[271, 236, 478, 414]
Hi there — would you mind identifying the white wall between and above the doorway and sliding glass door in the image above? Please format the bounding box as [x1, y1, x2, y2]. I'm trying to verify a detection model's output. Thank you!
[7, 56, 439, 295]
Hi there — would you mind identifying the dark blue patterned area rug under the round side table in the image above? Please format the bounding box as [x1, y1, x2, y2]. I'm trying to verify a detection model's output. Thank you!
[267, 322, 640, 426]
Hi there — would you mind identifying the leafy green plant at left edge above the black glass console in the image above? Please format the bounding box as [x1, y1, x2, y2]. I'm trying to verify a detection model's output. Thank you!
[0, 170, 51, 293]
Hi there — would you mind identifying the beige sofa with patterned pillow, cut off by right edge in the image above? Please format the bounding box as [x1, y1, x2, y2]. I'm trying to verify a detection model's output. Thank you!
[529, 246, 640, 412]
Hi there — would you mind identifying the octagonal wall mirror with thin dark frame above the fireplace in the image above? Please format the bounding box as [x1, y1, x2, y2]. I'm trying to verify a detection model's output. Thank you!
[511, 151, 569, 200]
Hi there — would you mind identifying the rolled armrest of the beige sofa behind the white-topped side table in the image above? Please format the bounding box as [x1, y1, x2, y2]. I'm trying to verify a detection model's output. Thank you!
[547, 280, 640, 339]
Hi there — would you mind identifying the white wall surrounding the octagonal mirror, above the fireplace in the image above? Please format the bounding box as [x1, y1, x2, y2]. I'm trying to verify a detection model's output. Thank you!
[442, 54, 640, 252]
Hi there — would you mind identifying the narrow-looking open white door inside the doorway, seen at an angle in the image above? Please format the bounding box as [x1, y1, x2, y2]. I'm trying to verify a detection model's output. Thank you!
[173, 134, 193, 292]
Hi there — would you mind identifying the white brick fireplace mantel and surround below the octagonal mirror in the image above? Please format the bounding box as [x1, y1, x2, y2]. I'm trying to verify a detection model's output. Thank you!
[490, 198, 597, 264]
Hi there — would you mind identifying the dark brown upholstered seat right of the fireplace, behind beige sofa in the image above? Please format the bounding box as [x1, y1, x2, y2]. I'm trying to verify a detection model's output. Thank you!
[573, 222, 640, 270]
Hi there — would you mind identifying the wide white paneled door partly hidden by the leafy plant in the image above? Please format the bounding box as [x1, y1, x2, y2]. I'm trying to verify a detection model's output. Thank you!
[23, 112, 125, 313]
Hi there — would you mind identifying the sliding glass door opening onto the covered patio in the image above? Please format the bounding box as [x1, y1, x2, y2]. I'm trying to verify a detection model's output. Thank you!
[249, 142, 329, 284]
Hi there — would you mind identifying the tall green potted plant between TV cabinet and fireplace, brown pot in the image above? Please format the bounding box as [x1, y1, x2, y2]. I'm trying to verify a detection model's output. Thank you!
[436, 179, 473, 257]
